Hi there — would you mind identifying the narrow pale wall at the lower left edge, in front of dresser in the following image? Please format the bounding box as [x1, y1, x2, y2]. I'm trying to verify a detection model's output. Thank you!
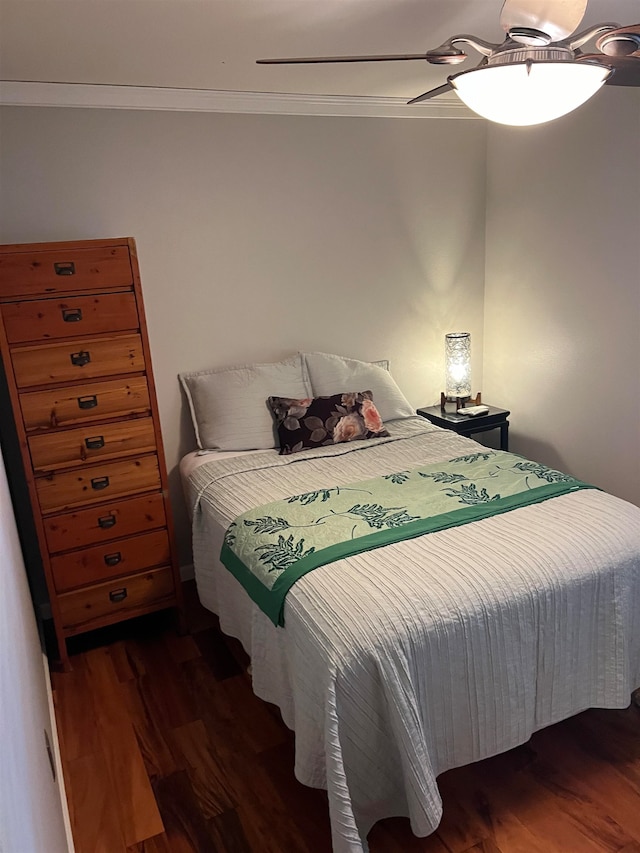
[0, 442, 70, 853]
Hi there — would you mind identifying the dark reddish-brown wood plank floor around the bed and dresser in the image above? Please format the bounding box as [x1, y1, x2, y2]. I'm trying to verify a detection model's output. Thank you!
[53, 584, 640, 853]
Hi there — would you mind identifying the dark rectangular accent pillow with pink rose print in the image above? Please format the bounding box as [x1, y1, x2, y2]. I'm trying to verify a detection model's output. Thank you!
[267, 391, 389, 455]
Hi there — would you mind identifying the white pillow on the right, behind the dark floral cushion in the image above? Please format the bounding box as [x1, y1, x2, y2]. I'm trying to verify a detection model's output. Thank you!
[303, 352, 416, 421]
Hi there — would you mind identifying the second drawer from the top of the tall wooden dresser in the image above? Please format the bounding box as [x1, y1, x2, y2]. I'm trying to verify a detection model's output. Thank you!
[1, 293, 140, 344]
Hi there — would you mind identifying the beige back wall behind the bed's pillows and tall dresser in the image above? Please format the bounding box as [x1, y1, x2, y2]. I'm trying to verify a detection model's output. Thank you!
[0, 108, 486, 562]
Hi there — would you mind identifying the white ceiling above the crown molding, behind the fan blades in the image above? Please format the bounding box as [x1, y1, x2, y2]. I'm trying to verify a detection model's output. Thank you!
[0, 0, 640, 99]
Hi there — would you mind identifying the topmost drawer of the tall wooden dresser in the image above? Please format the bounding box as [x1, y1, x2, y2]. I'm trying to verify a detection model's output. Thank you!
[0, 246, 133, 298]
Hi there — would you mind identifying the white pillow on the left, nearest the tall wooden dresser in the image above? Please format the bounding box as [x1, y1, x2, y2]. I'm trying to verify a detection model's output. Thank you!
[179, 354, 312, 450]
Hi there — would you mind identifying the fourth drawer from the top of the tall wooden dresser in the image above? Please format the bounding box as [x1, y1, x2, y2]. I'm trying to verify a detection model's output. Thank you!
[20, 376, 151, 432]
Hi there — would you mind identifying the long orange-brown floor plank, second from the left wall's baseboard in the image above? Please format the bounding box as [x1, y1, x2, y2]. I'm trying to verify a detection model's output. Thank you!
[85, 649, 164, 846]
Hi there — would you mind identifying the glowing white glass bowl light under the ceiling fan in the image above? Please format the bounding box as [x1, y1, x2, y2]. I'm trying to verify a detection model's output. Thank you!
[449, 59, 612, 126]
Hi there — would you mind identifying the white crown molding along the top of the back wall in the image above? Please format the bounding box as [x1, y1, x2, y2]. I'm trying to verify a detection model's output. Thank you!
[0, 80, 478, 119]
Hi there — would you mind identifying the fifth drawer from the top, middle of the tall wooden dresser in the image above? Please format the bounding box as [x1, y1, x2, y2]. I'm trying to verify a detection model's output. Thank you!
[29, 418, 156, 473]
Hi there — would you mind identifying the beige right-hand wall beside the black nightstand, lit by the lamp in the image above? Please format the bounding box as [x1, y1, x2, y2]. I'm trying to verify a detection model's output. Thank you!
[484, 87, 640, 504]
